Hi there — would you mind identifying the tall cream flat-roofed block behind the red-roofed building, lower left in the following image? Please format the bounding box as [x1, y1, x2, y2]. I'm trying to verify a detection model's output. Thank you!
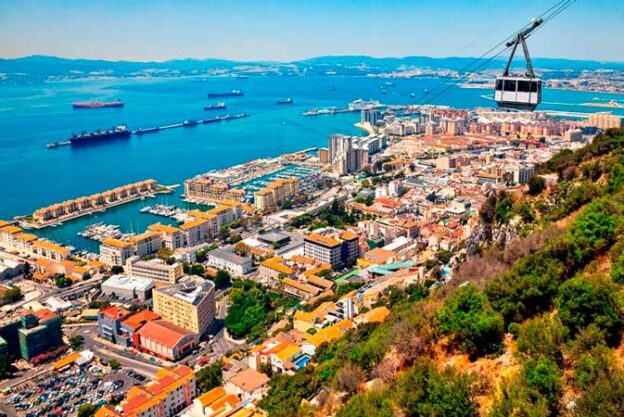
[153, 278, 216, 337]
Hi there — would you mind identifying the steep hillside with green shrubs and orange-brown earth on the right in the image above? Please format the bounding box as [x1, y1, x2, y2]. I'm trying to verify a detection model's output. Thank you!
[260, 130, 624, 417]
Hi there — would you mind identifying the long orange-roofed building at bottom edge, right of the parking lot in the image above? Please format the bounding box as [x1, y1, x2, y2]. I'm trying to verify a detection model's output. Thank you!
[95, 365, 197, 417]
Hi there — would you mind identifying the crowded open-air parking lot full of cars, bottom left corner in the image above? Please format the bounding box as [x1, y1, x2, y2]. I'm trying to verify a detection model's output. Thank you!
[2, 365, 146, 417]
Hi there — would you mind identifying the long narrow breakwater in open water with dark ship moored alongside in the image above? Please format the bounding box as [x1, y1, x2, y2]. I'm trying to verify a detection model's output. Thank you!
[46, 113, 250, 149]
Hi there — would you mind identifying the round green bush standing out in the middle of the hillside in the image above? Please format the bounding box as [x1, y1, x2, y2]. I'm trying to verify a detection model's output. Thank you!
[436, 284, 504, 355]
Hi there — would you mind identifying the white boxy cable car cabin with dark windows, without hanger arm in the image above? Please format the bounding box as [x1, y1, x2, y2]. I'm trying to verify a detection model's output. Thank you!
[494, 75, 542, 111]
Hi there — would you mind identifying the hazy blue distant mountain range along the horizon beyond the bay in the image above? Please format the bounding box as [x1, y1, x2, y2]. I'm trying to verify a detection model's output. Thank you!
[0, 55, 624, 78]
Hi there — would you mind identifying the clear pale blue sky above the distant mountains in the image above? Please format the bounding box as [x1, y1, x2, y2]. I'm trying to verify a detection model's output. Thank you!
[0, 0, 624, 62]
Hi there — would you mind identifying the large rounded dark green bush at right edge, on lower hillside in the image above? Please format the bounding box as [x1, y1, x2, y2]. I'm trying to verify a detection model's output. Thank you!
[557, 274, 623, 343]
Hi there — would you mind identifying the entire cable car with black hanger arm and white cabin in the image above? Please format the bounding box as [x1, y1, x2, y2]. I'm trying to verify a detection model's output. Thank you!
[494, 19, 544, 111]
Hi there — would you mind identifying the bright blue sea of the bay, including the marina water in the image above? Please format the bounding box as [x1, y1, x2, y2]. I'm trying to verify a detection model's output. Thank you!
[0, 76, 624, 251]
